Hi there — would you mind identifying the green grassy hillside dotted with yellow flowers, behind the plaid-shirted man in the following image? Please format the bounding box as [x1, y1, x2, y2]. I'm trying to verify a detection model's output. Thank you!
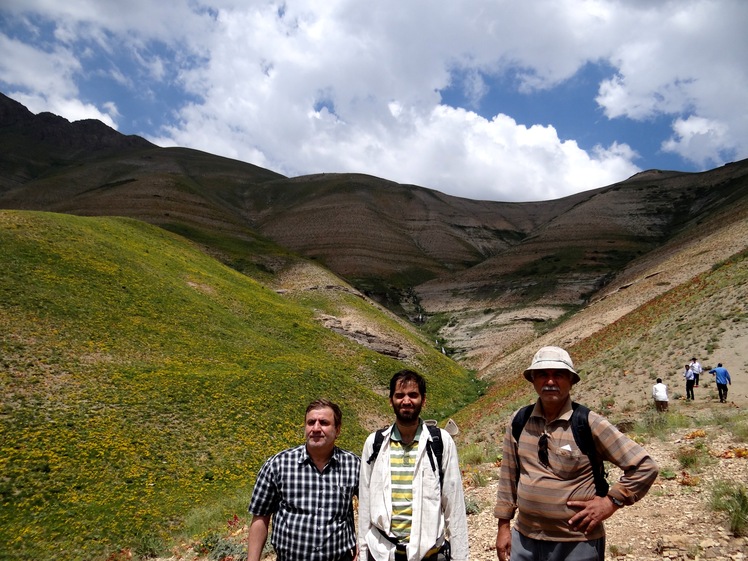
[0, 211, 477, 560]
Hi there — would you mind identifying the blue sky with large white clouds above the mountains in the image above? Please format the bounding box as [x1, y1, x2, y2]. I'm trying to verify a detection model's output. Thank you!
[0, 0, 748, 201]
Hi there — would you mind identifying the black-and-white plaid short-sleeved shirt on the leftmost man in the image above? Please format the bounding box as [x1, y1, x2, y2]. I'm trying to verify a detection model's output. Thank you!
[249, 445, 361, 561]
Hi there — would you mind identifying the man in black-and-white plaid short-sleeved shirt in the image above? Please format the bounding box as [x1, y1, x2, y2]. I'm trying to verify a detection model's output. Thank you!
[247, 399, 360, 561]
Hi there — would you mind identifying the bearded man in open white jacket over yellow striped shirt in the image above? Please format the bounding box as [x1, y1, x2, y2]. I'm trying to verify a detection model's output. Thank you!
[358, 370, 468, 561]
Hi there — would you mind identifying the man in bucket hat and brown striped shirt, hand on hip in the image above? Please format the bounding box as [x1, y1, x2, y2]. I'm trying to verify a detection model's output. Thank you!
[494, 347, 658, 561]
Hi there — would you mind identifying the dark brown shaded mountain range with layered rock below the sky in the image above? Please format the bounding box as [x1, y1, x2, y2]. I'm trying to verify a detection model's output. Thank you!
[0, 92, 748, 378]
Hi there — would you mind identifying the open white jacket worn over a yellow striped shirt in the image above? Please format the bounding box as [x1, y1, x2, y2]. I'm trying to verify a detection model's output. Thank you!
[358, 424, 468, 561]
